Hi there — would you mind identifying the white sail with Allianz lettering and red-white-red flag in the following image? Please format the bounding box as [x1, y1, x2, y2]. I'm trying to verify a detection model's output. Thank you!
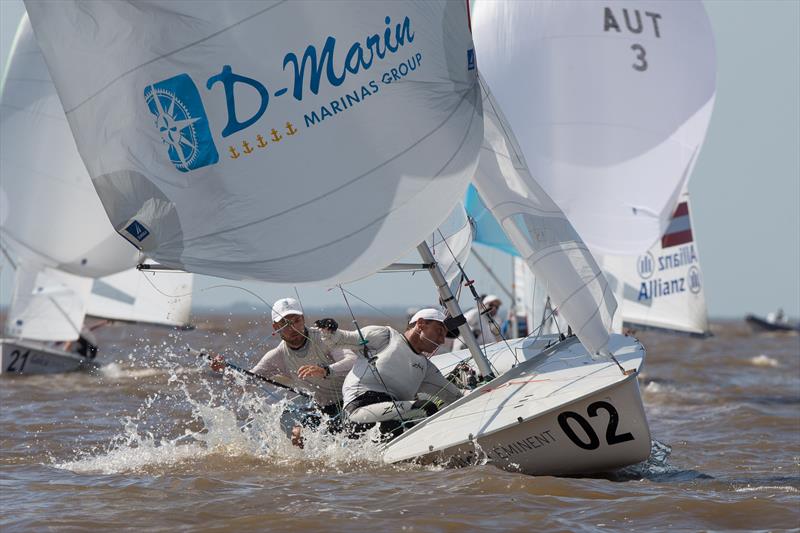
[598, 189, 709, 336]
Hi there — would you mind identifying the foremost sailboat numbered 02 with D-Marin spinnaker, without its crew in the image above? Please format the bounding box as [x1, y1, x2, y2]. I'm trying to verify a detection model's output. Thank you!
[26, 0, 708, 473]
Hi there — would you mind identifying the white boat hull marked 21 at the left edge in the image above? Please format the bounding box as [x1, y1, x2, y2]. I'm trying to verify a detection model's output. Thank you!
[0, 339, 93, 375]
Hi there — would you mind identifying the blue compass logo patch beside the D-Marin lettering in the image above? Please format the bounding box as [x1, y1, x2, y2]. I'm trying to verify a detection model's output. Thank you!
[144, 74, 219, 172]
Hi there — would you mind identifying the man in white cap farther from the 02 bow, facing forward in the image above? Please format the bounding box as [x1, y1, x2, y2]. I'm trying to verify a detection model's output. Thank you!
[211, 298, 356, 448]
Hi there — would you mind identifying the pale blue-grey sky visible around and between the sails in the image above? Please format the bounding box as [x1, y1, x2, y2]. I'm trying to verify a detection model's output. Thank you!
[0, 0, 800, 318]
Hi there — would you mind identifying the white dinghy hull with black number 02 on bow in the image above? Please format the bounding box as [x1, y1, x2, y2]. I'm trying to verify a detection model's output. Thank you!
[384, 335, 650, 475]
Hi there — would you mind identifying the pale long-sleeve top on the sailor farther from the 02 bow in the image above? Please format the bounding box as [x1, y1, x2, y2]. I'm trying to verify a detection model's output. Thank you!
[250, 328, 356, 406]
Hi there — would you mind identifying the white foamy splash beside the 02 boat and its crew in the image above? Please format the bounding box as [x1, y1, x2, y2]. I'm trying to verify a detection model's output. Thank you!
[54, 362, 382, 474]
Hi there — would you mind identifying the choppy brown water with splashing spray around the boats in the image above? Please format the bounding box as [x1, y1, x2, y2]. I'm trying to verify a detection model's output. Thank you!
[0, 318, 800, 532]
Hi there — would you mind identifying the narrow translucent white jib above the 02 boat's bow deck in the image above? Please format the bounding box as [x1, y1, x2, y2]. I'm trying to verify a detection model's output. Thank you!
[474, 80, 617, 354]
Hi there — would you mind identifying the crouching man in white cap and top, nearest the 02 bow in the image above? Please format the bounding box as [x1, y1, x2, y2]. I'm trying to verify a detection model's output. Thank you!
[337, 308, 462, 438]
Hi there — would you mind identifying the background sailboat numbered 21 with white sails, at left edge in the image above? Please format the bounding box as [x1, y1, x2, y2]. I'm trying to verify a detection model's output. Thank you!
[0, 16, 192, 375]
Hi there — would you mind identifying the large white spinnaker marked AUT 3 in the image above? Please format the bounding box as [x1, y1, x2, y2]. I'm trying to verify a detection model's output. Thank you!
[472, 0, 716, 255]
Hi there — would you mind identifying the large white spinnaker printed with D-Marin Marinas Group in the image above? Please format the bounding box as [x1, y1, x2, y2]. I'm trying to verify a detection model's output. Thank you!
[26, 0, 483, 283]
